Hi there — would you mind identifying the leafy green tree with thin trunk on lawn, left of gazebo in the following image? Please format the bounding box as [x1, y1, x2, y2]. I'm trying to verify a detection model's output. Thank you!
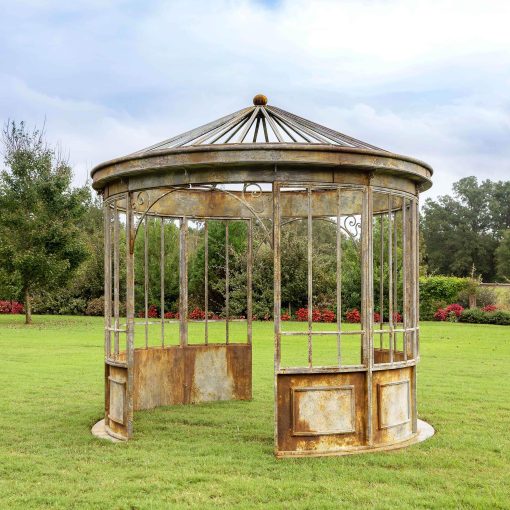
[0, 122, 89, 324]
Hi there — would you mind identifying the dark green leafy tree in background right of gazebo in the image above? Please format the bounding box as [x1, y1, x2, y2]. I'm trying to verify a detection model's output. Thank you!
[422, 177, 510, 281]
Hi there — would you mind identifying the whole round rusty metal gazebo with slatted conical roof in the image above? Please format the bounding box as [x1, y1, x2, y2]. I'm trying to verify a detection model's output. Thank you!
[92, 95, 433, 457]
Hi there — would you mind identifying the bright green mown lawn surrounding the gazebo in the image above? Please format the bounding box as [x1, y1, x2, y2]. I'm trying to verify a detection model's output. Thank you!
[0, 316, 510, 509]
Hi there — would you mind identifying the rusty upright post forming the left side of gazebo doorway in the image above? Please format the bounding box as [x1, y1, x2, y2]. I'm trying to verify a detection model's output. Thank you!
[126, 193, 135, 437]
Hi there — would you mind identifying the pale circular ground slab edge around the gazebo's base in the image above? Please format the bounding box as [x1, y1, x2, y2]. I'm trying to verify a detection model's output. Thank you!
[91, 419, 436, 458]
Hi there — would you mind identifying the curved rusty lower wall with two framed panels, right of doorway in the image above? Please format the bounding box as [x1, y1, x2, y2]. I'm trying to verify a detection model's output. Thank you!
[276, 367, 416, 456]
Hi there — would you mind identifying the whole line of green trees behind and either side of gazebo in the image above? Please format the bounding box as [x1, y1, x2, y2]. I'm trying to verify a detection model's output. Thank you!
[0, 122, 510, 322]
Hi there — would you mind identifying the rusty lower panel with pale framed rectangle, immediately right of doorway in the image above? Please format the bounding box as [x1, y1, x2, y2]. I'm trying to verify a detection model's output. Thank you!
[277, 371, 366, 455]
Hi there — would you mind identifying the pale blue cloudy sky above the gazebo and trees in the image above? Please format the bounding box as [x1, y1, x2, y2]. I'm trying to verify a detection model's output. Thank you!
[0, 0, 510, 196]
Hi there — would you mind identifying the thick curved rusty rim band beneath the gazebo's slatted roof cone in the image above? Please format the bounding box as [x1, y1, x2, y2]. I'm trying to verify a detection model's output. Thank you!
[92, 143, 432, 194]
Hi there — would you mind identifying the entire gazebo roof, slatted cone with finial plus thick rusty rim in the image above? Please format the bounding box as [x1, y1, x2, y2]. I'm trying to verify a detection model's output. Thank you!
[91, 94, 432, 190]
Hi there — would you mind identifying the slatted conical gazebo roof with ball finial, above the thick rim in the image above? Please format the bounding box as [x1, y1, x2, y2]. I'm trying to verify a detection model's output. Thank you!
[126, 94, 382, 156]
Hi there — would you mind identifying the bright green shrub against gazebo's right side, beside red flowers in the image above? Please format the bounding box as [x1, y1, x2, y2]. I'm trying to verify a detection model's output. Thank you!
[420, 276, 478, 320]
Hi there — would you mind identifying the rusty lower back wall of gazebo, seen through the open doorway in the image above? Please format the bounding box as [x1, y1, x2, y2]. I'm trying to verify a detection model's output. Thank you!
[134, 343, 252, 410]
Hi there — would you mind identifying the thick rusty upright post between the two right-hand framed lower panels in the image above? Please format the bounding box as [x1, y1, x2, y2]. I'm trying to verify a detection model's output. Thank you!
[361, 186, 374, 445]
